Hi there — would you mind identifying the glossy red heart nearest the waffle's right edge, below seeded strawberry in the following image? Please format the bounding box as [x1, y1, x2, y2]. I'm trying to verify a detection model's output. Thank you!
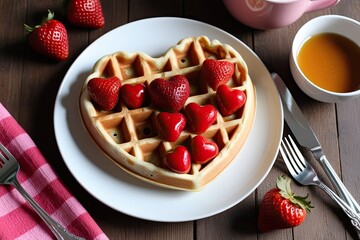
[216, 85, 246, 116]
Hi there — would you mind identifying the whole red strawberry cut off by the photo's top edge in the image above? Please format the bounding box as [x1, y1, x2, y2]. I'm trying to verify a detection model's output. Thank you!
[65, 0, 105, 28]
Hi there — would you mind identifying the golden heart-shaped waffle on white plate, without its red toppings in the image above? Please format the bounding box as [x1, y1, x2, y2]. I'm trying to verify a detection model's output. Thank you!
[80, 36, 256, 191]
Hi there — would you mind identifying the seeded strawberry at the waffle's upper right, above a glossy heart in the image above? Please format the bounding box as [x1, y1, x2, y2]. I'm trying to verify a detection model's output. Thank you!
[200, 58, 235, 91]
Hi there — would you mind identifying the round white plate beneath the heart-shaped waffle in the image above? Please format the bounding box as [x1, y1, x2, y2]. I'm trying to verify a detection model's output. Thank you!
[54, 17, 283, 222]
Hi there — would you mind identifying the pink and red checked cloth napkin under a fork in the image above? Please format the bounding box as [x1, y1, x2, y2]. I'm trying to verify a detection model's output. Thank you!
[0, 103, 108, 240]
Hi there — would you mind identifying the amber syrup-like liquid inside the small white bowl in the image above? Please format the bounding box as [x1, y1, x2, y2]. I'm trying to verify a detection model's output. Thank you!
[297, 33, 360, 93]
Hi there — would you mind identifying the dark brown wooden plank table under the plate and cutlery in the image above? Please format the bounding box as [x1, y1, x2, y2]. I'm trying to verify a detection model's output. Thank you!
[0, 0, 360, 240]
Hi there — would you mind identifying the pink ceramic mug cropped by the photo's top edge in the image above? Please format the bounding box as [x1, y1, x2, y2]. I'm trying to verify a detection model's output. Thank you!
[223, 0, 340, 30]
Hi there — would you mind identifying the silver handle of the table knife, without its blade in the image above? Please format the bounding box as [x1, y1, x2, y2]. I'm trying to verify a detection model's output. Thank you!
[313, 151, 360, 213]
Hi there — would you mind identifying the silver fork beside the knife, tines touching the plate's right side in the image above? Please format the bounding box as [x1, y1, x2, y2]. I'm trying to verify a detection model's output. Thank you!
[280, 135, 360, 230]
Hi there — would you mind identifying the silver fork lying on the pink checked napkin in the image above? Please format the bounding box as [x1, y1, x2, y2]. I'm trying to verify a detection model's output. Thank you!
[0, 143, 84, 240]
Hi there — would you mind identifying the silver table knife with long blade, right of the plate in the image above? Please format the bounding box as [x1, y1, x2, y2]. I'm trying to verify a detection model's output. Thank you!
[271, 73, 360, 213]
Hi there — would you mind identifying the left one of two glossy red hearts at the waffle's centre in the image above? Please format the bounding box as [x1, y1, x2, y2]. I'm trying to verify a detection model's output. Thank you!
[155, 112, 186, 142]
